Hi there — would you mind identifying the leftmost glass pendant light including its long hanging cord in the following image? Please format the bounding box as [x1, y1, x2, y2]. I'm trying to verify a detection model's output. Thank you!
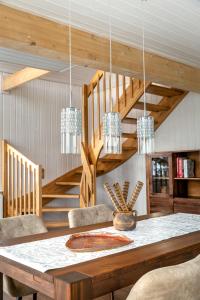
[61, 0, 81, 154]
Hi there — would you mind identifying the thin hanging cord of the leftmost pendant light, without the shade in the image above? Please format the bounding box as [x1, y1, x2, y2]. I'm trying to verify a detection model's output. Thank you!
[68, 0, 72, 107]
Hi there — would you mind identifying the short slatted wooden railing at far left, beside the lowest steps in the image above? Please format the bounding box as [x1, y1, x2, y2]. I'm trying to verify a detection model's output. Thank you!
[1, 140, 42, 217]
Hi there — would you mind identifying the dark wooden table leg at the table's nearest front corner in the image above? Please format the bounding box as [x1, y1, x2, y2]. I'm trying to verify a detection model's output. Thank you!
[54, 272, 92, 300]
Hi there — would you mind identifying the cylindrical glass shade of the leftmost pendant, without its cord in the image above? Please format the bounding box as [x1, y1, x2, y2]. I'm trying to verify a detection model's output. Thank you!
[61, 107, 81, 154]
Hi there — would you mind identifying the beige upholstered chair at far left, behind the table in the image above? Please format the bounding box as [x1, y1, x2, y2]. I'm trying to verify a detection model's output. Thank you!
[0, 215, 47, 300]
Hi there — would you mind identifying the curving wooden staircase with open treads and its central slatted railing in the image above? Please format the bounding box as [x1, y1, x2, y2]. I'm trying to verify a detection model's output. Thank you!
[42, 71, 187, 228]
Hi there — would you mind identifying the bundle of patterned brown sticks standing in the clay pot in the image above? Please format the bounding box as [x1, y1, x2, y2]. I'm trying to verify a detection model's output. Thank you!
[104, 181, 143, 212]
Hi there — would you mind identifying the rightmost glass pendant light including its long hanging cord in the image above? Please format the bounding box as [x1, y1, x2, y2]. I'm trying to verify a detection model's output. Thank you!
[137, 0, 154, 154]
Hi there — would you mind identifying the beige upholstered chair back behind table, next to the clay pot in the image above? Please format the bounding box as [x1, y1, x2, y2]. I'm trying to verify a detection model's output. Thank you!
[68, 204, 113, 228]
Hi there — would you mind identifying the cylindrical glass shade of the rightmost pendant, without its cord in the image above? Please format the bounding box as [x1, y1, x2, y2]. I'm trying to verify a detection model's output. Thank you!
[137, 116, 154, 154]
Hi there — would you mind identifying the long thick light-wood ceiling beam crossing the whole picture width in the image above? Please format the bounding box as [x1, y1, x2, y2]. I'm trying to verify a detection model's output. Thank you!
[0, 5, 200, 92]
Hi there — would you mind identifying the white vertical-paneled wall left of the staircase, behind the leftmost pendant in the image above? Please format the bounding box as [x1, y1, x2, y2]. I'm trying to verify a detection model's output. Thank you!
[0, 74, 81, 183]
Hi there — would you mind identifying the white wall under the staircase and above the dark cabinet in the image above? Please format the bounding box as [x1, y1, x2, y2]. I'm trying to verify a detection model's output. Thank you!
[97, 93, 200, 214]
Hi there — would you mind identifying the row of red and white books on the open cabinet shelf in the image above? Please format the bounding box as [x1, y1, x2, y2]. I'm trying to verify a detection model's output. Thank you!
[176, 157, 194, 178]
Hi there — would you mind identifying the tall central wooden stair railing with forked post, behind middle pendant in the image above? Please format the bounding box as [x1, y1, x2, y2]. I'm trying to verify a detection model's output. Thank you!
[80, 71, 143, 207]
